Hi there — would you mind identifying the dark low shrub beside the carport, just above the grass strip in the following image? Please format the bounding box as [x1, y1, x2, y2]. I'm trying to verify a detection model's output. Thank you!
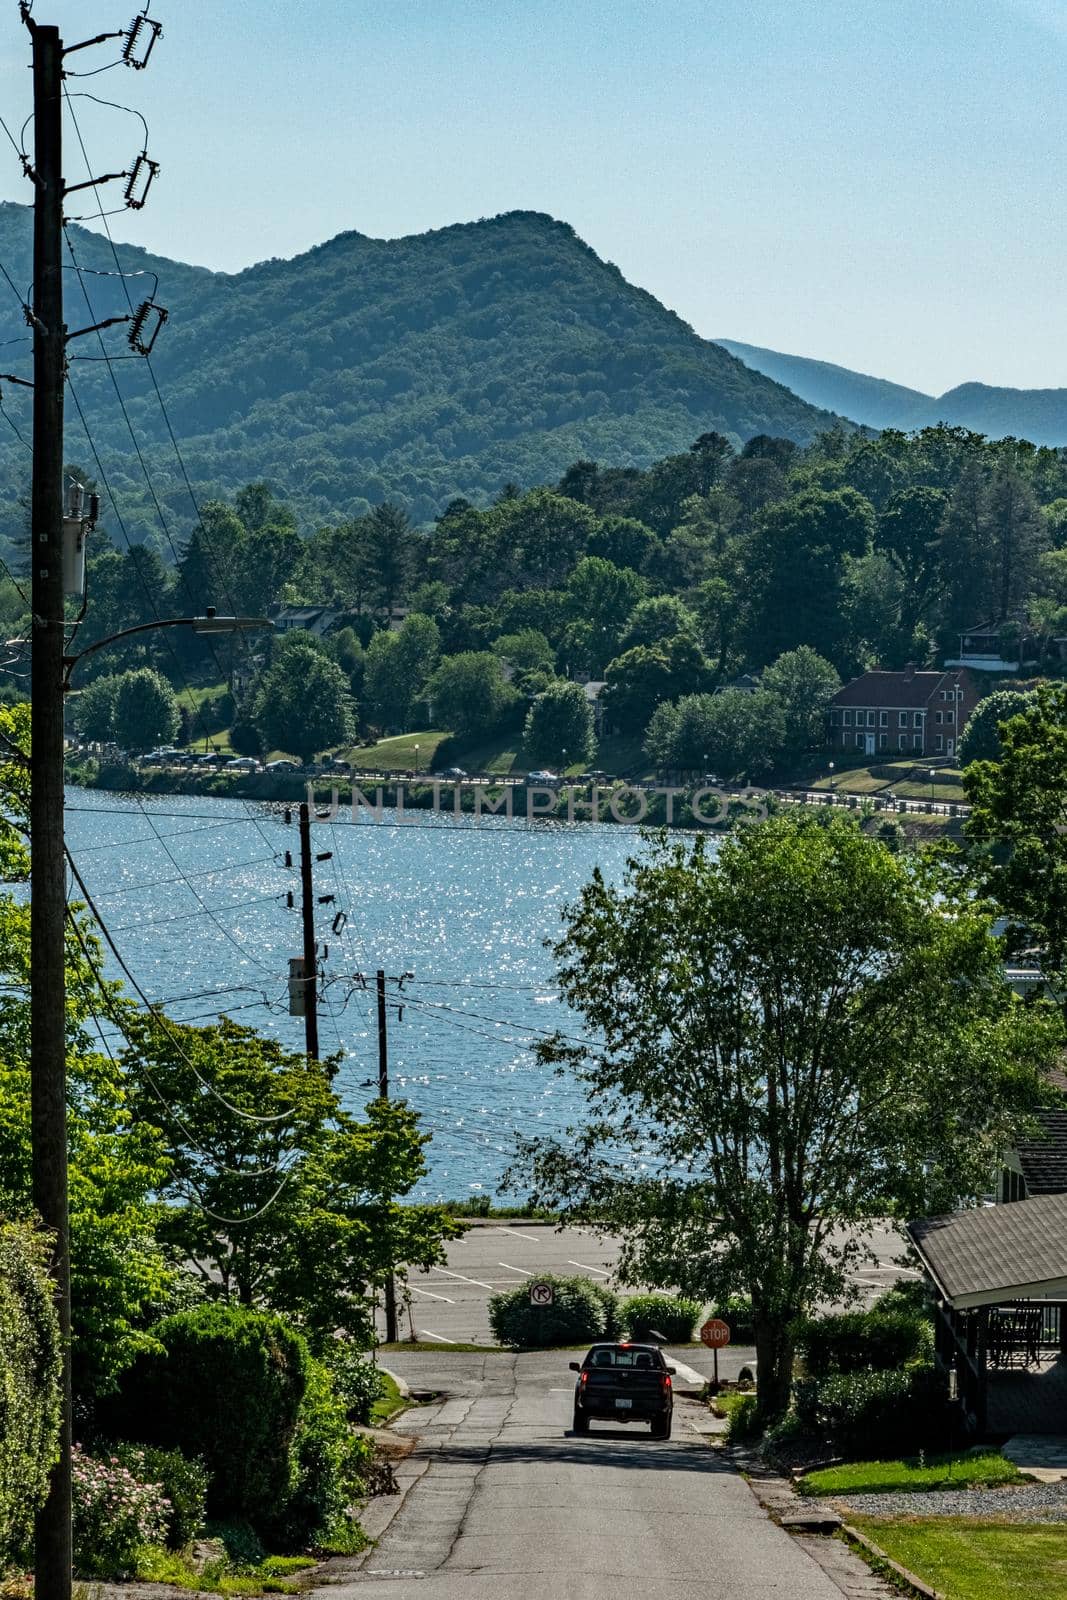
[795, 1365, 949, 1459]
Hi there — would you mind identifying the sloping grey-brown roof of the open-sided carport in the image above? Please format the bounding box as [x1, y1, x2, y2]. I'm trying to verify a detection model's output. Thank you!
[907, 1194, 1067, 1310]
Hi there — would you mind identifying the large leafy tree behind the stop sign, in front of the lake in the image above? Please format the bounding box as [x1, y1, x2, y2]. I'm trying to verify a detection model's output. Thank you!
[518, 814, 1059, 1419]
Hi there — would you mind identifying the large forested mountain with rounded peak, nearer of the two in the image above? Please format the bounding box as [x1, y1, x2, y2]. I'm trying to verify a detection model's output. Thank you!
[0, 205, 835, 530]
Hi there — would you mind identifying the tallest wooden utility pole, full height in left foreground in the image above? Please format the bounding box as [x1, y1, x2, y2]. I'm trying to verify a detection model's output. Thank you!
[26, 16, 70, 1600]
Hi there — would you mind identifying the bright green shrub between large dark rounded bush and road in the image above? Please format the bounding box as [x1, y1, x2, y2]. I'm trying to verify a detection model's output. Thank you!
[267, 1362, 371, 1550]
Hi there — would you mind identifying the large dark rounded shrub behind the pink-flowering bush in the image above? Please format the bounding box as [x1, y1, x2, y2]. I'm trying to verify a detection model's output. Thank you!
[102, 1306, 310, 1530]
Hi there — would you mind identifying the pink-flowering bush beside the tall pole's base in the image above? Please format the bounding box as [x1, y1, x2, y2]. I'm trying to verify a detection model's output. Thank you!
[74, 1445, 171, 1578]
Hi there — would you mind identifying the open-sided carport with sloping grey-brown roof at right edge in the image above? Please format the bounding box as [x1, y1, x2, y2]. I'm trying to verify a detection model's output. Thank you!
[907, 1194, 1067, 1434]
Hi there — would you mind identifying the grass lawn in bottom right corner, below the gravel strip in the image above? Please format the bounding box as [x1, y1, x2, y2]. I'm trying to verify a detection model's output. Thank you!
[856, 1517, 1067, 1600]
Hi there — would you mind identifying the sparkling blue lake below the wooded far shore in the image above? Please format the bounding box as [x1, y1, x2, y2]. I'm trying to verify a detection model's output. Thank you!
[67, 789, 675, 1198]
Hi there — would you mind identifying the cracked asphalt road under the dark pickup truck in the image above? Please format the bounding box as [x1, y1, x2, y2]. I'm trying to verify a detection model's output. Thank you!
[318, 1350, 888, 1600]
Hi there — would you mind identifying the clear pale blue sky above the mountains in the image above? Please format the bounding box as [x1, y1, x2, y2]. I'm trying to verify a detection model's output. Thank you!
[0, 0, 1067, 392]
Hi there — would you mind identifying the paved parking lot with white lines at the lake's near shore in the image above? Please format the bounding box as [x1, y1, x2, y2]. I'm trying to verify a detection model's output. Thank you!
[379, 1221, 913, 1347]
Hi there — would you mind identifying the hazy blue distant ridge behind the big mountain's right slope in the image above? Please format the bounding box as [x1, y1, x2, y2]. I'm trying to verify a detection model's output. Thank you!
[717, 339, 1067, 445]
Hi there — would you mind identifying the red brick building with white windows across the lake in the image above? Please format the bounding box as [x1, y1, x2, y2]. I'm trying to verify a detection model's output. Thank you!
[830, 667, 979, 758]
